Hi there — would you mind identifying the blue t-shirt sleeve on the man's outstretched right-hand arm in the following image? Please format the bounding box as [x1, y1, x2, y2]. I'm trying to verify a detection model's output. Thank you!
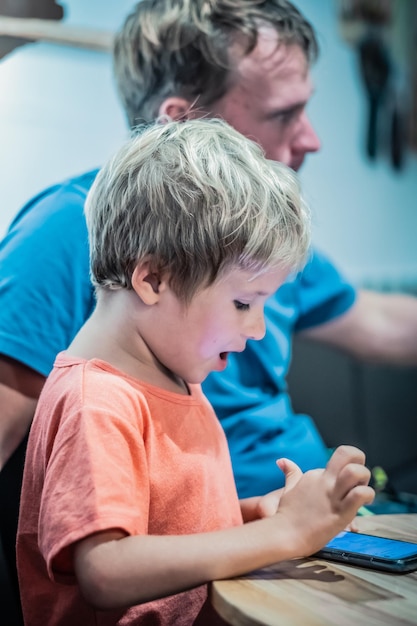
[294, 250, 356, 332]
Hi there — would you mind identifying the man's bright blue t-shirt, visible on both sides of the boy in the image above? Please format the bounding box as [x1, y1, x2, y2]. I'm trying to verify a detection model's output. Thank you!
[0, 170, 355, 497]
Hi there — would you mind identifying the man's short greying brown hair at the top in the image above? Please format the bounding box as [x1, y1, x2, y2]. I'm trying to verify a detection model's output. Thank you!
[114, 0, 318, 127]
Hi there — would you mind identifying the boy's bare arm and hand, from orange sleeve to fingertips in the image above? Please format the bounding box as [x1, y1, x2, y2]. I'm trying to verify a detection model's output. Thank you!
[74, 446, 374, 609]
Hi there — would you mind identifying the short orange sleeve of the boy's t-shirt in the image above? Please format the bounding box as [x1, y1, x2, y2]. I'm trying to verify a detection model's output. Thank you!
[39, 384, 150, 578]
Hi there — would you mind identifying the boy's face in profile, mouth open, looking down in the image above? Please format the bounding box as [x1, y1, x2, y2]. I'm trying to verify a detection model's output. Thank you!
[148, 269, 287, 383]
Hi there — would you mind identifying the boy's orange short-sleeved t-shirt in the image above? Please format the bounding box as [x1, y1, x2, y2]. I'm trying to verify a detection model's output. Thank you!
[17, 353, 242, 626]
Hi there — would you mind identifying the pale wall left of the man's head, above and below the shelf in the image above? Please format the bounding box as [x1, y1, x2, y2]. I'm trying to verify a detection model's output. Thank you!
[0, 0, 134, 235]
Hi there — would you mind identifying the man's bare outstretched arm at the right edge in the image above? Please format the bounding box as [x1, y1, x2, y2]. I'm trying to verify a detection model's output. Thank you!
[300, 290, 417, 365]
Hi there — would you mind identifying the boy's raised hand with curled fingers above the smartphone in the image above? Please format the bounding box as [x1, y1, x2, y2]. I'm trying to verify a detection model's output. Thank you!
[277, 446, 375, 557]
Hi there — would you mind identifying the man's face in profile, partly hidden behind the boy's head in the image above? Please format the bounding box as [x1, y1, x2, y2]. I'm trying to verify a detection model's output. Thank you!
[202, 28, 320, 170]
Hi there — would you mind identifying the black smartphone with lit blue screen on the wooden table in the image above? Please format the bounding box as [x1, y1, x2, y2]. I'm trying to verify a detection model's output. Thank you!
[313, 531, 417, 573]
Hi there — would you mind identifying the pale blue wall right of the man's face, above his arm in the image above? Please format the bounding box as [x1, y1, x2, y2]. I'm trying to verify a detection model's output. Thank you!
[296, 0, 417, 289]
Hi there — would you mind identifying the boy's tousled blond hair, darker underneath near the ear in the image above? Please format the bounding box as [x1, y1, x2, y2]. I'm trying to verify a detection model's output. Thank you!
[86, 119, 310, 302]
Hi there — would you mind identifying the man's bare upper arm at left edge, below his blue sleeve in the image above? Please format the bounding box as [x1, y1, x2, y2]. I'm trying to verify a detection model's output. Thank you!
[0, 354, 45, 470]
